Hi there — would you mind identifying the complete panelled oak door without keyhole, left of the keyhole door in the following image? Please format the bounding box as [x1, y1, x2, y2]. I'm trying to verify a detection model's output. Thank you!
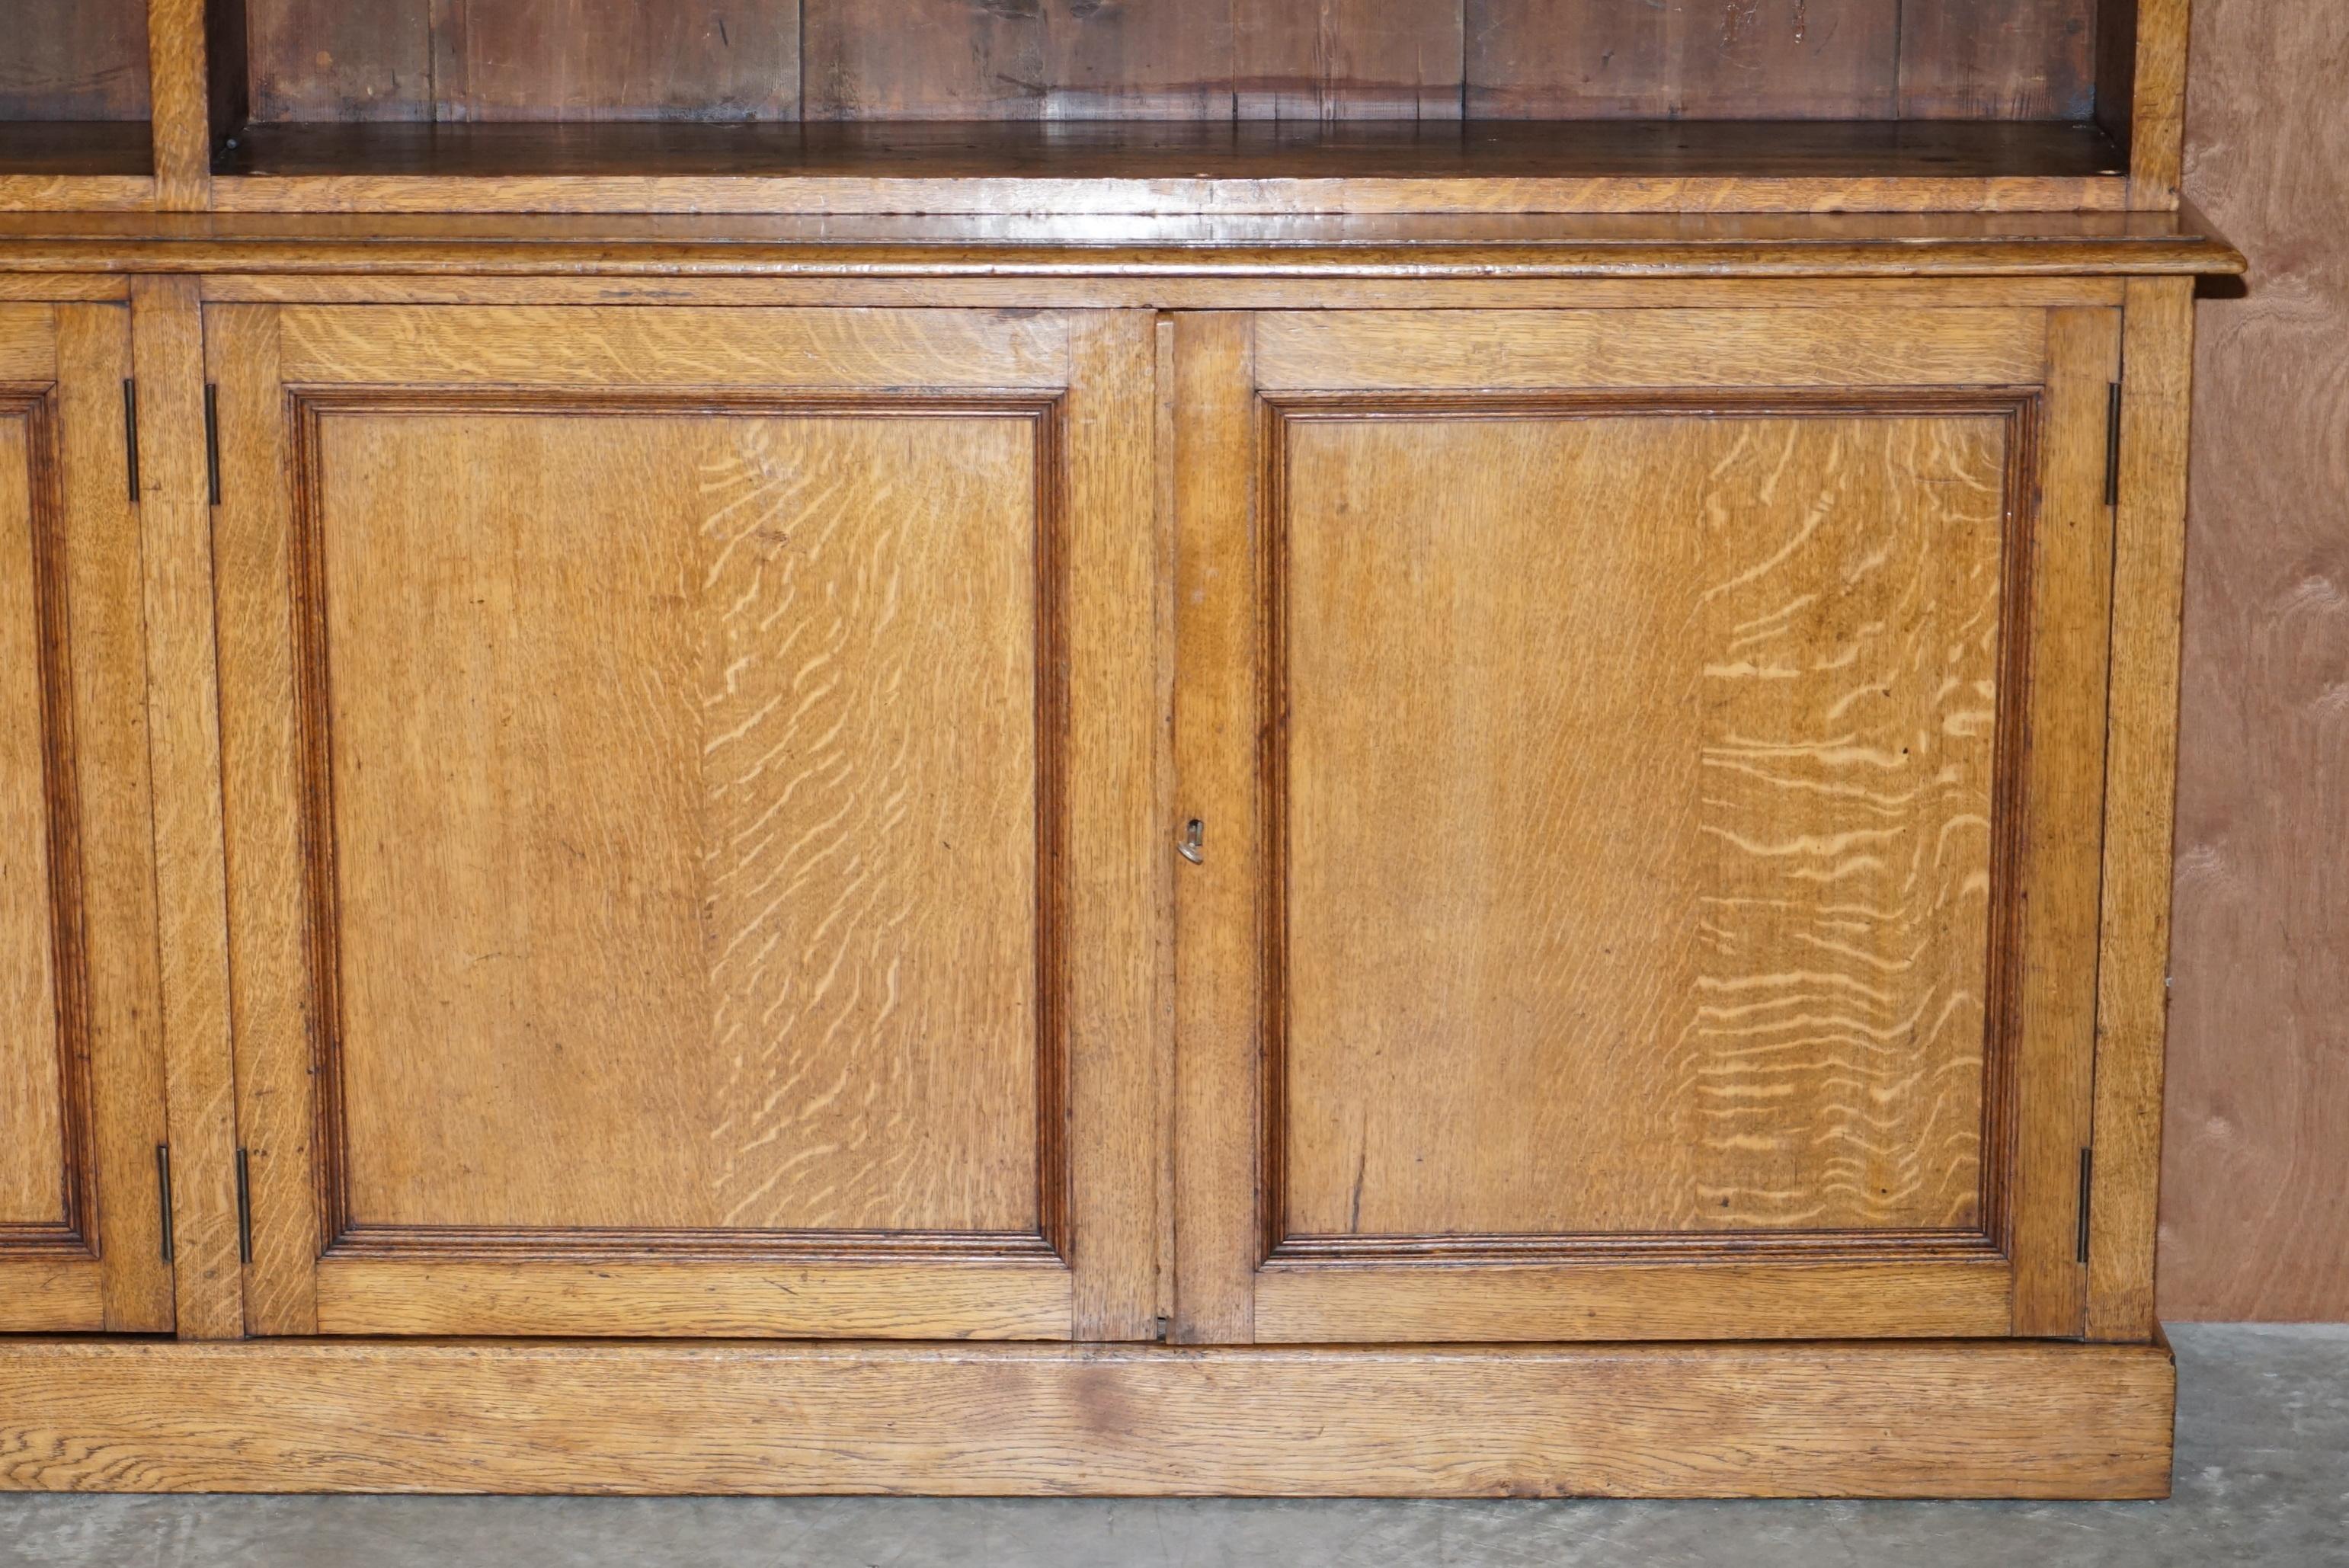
[204, 306, 1170, 1338]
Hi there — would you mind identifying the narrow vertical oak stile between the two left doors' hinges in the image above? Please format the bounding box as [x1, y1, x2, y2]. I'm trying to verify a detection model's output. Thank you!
[132, 277, 245, 1340]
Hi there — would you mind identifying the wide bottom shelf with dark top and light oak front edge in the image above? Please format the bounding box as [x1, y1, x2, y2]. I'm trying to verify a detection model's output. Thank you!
[214, 120, 2128, 216]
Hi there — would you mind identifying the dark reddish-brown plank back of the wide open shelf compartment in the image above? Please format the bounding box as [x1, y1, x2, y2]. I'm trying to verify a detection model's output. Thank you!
[233, 0, 2117, 122]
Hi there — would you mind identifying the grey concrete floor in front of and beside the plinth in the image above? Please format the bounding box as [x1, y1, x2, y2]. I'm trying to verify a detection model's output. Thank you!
[0, 1326, 2349, 1568]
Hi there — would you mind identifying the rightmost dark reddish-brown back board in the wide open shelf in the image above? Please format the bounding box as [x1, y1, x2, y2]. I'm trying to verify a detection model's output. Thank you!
[1900, 0, 2126, 120]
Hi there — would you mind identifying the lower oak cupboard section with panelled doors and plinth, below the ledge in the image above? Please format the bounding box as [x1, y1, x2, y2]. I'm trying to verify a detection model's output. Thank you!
[0, 282, 2187, 1498]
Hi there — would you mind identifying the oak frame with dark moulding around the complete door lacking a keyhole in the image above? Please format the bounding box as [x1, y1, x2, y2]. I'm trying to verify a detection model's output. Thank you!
[206, 306, 1167, 1340]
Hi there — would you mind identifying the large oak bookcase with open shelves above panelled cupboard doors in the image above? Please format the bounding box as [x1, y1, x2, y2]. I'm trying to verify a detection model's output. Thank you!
[0, 0, 2241, 1498]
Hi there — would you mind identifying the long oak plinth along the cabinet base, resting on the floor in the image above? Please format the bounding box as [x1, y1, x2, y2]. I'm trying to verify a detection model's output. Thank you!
[0, 1338, 2175, 1498]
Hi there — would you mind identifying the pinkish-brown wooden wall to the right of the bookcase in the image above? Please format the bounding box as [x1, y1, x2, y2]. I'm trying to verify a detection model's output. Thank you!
[2161, 0, 2349, 1322]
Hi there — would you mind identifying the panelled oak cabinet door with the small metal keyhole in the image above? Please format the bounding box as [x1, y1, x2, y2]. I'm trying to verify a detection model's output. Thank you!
[1175, 306, 2119, 1342]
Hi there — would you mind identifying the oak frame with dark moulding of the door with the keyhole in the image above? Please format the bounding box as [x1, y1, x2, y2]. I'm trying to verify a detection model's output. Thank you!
[1172, 308, 2119, 1342]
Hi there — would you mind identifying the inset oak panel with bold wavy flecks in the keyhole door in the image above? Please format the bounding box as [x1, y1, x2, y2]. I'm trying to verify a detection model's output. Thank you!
[1273, 402, 2027, 1249]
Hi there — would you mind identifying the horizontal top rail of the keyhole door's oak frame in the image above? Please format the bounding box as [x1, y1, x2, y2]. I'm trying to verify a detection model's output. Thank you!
[1256, 308, 2046, 392]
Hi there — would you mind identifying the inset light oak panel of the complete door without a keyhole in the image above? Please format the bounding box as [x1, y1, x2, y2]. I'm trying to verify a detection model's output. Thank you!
[306, 406, 1057, 1235]
